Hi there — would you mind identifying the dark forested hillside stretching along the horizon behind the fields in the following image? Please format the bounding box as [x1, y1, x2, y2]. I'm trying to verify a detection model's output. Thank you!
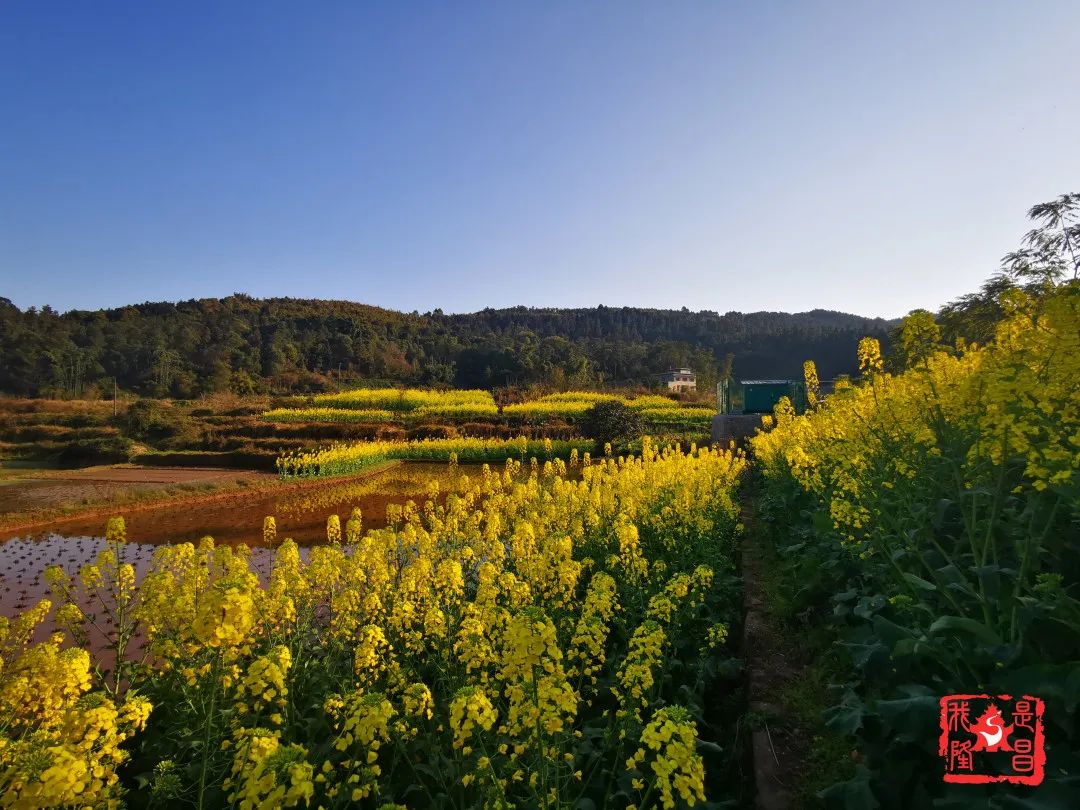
[0, 295, 891, 397]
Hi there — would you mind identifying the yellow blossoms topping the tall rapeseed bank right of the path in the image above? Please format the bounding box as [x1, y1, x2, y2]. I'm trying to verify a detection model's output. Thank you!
[753, 285, 1080, 540]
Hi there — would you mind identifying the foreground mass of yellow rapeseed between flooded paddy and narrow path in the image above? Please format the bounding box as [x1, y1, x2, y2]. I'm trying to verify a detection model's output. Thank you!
[10, 441, 745, 808]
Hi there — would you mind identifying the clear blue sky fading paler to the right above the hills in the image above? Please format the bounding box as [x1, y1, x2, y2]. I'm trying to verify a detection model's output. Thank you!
[0, 0, 1080, 316]
